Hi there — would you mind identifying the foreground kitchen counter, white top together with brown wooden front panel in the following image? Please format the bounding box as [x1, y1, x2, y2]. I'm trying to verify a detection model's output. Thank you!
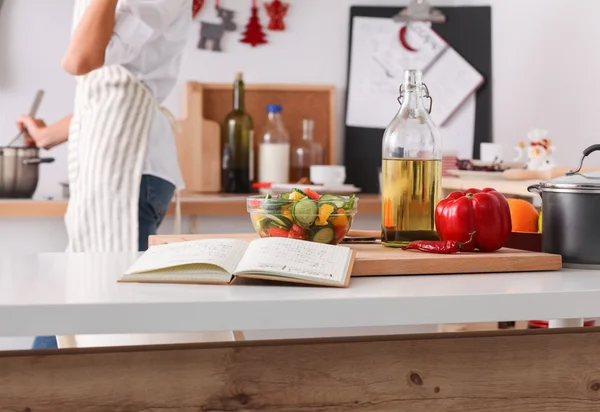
[0, 254, 600, 412]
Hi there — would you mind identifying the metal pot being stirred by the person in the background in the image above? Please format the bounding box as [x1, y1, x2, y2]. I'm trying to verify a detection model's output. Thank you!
[0, 147, 54, 199]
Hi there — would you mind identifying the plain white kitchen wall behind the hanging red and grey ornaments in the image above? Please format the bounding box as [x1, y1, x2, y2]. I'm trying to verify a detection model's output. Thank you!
[0, 0, 600, 197]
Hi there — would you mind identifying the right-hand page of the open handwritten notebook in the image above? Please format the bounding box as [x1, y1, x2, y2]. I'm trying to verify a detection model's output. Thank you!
[236, 238, 352, 284]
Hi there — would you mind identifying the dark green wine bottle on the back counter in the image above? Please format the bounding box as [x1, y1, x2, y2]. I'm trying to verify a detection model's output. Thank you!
[221, 73, 254, 193]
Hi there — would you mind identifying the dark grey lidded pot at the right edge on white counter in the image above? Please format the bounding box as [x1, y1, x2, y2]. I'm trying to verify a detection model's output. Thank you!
[528, 144, 600, 269]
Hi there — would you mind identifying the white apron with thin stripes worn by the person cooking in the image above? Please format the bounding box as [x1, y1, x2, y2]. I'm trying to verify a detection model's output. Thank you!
[65, 66, 157, 252]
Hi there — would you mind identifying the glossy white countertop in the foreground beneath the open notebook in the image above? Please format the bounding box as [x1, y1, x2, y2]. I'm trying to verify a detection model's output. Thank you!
[0, 253, 600, 336]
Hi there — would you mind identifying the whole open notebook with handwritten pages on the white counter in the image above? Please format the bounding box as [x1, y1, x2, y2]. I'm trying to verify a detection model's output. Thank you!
[119, 238, 355, 287]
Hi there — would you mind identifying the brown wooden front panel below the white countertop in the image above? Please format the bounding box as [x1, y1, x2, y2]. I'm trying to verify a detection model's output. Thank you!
[0, 328, 600, 412]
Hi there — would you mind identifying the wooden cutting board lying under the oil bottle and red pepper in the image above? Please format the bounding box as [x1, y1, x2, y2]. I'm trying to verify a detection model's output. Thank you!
[150, 234, 562, 276]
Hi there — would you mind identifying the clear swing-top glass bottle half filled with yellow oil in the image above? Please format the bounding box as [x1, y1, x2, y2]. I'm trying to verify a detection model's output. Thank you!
[381, 70, 442, 247]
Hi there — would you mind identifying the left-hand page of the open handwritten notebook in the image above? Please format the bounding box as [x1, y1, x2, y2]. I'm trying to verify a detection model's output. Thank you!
[126, 239, 248, 275]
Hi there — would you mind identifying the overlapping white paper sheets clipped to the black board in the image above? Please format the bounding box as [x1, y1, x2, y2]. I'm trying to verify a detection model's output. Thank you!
[346, 16, 484, 158]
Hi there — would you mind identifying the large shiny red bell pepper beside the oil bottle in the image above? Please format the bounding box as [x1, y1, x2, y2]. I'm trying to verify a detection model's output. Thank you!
[435, 189, 512, 252]
